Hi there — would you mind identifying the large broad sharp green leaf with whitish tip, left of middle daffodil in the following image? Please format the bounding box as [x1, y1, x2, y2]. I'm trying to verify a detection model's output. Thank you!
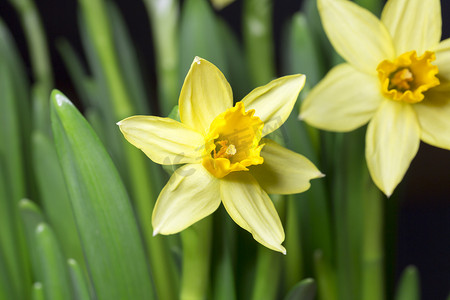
[51, 90, 153, 299]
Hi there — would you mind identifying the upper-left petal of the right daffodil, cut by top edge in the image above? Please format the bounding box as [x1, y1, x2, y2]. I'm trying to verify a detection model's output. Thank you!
[318, 0, 395, 74]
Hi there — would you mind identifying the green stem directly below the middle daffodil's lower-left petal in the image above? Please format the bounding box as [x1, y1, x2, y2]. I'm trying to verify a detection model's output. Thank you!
[180, 216, 212, 300]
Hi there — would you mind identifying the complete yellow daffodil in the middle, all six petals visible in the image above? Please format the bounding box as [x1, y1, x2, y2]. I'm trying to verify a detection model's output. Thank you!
[118, 57, 322, 253]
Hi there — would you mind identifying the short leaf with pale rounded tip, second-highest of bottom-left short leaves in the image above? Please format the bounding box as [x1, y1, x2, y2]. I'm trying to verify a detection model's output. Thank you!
[35, 223, 73, 300]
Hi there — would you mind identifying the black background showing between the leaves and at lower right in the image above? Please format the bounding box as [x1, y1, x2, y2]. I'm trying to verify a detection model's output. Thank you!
[0, 0, 450, 300]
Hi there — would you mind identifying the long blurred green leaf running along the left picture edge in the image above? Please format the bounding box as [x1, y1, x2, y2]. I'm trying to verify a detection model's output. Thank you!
[0, 61, 29, 297]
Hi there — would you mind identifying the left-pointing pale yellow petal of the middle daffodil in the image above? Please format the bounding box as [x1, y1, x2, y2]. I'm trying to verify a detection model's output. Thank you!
[117, 116, 204, 165]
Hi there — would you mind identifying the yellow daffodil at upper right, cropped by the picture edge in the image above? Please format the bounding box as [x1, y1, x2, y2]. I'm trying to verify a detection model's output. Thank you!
[300, 0, 450, 196]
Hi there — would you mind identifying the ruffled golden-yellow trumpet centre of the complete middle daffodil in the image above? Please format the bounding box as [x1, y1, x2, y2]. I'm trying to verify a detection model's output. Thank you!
[202, 102, 264, 178]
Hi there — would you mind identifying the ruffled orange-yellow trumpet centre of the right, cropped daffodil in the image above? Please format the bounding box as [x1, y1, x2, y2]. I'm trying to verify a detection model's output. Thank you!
[377, 51, 439, 103]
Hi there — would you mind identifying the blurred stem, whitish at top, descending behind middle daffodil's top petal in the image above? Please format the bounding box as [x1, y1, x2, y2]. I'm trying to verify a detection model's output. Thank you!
[144, 0, 180, 115]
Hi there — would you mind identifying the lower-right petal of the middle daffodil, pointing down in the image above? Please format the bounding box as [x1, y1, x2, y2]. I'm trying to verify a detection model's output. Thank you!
[220, 172, 286, 253]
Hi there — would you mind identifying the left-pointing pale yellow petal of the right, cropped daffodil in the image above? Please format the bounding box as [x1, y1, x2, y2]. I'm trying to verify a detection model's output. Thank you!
[300, 64, 383, 131]
